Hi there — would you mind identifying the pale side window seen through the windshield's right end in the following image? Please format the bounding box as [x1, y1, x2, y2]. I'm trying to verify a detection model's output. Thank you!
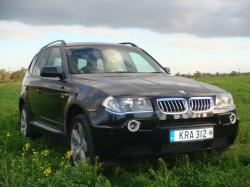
[129, 52, 155, 72]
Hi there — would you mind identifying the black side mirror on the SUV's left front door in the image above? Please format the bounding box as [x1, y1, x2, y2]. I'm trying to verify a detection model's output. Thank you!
[40, 66, 63, 79]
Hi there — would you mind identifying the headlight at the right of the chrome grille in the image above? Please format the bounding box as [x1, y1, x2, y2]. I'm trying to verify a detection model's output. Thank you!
[214, 93, 235, 110]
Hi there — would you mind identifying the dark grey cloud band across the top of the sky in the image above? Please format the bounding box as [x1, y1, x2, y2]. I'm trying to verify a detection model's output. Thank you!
[0, 0, 250, 37]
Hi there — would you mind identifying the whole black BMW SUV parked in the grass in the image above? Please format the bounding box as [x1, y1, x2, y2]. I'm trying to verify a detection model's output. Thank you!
[19, 40, 239, 164]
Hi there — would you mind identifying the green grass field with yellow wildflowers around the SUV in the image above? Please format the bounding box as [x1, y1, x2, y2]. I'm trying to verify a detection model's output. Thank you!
[0, 76, 250, 187]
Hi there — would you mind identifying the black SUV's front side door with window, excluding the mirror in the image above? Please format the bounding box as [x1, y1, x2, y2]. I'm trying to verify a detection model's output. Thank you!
[40, 47, 69, 130]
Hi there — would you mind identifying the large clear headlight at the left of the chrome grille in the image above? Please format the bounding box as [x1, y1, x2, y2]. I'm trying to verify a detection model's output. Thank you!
[102, 96, 153, 114]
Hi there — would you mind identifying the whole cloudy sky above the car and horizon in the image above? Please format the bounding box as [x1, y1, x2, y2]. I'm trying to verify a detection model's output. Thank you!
[0, 0, 250, 73]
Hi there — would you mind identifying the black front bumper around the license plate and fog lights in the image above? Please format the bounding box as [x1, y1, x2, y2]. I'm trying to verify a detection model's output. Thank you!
[93, 111, 239, 157]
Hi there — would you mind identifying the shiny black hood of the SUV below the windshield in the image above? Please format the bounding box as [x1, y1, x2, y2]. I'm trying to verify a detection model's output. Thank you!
[73, 73, 225, 96]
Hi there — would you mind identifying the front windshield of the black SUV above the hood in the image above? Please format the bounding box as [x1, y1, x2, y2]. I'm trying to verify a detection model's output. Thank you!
[67, 46, 165, 74]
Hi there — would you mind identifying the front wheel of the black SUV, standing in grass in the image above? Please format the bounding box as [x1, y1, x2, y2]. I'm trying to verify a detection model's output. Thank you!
[68, 114, 95, 166]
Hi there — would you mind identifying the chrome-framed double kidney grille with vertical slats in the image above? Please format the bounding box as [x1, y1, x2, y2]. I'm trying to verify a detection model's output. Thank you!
[157, 97, 213, 114]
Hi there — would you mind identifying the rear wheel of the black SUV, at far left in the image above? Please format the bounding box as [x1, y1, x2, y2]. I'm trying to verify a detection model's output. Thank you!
[20, 104, 36, 138]
